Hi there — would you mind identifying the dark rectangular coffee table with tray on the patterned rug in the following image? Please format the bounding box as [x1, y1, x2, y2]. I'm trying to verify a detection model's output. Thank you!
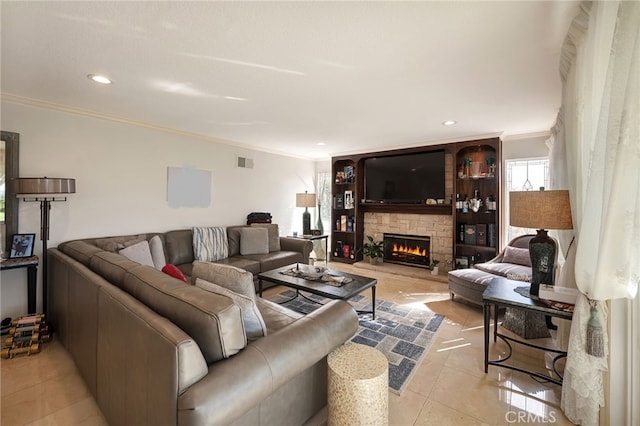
[258, 263, 378, 320]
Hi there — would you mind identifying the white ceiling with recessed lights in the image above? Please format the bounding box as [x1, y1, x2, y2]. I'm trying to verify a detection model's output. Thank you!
[1, 1, 578, 159]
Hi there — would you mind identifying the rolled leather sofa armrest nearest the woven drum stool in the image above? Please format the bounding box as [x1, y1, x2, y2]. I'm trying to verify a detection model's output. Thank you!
[178, 300, 358, 425]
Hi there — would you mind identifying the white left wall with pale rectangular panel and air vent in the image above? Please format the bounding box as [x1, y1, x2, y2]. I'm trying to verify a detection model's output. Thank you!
[0, 102, 315, 318]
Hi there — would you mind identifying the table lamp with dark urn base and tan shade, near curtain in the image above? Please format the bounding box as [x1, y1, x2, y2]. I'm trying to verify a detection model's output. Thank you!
[509, 188, 573, 298]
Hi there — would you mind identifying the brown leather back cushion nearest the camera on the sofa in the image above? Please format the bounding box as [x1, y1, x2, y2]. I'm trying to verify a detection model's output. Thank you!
[124, 265, 247, 364]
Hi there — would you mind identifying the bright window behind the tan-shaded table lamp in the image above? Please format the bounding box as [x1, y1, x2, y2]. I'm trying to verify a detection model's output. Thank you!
[504, 158, 549, 242]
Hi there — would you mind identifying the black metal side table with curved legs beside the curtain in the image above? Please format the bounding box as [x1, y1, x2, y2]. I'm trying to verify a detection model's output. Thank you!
[482, 278, 573, 385]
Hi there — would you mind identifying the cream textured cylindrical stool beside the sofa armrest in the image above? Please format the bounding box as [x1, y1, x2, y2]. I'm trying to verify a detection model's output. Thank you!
[327, 343, 389, 425]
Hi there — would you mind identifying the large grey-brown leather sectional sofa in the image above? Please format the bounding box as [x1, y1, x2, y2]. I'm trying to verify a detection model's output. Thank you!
[48, 225, 358, 425]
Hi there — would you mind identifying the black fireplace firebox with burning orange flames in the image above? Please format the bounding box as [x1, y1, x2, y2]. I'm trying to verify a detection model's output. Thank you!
[383, 233, 431, 268]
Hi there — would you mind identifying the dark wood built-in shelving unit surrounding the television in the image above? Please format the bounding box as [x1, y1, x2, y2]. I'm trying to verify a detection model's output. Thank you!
[331, 138, 502, 267]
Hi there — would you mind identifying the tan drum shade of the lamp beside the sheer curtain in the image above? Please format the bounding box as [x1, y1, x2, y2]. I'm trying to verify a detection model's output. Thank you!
[509, 190, 573, 229]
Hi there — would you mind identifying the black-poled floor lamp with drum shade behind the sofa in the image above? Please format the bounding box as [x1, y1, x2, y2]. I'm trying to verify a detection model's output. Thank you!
[15, 176, 76, 315]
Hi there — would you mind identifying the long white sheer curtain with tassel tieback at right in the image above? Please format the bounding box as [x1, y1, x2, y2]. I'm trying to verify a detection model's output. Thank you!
[551, 2, 640, 425]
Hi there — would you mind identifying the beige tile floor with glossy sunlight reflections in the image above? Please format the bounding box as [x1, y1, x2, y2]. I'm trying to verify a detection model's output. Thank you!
[0, 263, 571, 426]
